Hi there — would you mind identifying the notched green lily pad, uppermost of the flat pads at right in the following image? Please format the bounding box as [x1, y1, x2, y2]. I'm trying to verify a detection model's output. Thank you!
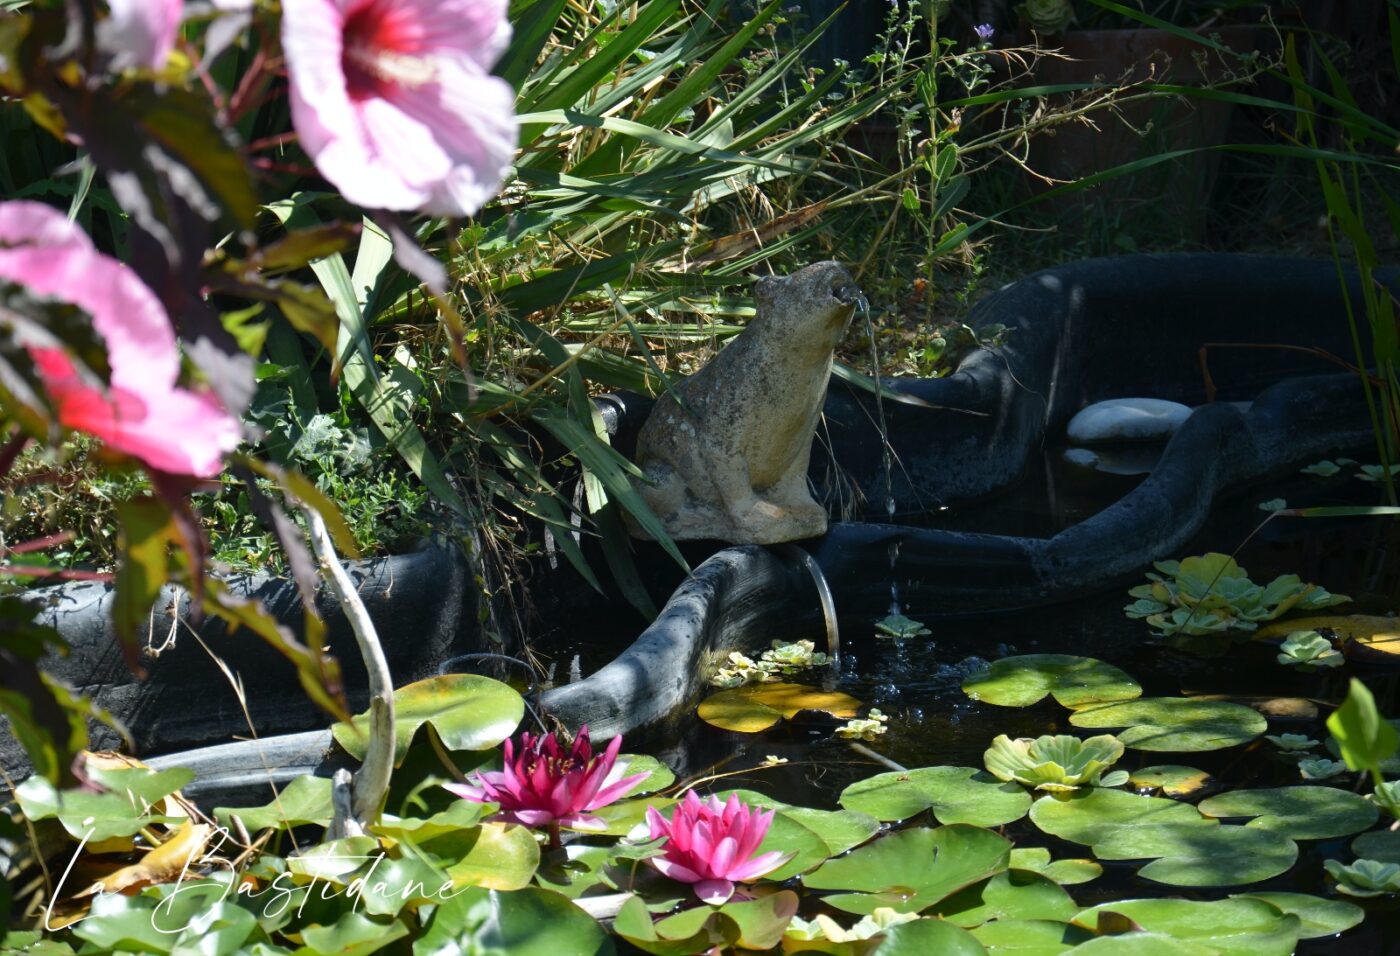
[962, 654, 1142, 708]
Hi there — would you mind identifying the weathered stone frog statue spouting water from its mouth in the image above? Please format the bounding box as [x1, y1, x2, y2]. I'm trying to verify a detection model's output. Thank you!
[633, 262, 860, 544]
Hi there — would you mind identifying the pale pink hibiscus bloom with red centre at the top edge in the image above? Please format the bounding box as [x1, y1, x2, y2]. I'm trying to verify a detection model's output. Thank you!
[281, 0, 517, 216]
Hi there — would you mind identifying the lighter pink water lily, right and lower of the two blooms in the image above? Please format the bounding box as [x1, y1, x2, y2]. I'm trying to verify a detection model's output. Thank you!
[647, 791, 792, 904]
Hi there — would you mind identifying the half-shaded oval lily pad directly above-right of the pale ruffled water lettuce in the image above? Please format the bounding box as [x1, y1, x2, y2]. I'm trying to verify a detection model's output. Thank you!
[1070, 697, 1268, 753]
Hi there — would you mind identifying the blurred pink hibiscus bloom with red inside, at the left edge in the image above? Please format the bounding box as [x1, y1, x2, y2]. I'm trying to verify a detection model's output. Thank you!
[0, 202, 241, 477]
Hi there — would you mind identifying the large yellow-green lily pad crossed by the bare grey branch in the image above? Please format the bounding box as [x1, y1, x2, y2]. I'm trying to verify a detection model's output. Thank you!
[330, 673, 525, 766]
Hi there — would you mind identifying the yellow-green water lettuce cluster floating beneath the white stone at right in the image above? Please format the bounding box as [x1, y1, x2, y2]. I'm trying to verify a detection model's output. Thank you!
[1124, 551, 1350, 637]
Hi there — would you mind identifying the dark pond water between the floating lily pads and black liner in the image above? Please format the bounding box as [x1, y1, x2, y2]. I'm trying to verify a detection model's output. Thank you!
[523, 449, 1400, 953]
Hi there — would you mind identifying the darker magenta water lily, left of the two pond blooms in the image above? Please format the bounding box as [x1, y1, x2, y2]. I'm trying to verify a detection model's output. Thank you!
[445, 726, 651, 830]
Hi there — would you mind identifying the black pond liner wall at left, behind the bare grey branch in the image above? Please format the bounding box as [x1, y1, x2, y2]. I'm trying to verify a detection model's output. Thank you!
[0, 547, 486, 775]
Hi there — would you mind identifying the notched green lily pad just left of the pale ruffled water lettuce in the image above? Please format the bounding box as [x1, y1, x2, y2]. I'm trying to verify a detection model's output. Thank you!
[840, 767, 1030, 827]
